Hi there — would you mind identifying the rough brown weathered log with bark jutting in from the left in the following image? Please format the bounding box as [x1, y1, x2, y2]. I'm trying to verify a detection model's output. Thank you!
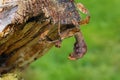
[0, 0, 80, 77]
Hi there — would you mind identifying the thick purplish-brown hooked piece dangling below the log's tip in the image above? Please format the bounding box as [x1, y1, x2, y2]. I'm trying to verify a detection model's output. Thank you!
[68, 32, 87, 60]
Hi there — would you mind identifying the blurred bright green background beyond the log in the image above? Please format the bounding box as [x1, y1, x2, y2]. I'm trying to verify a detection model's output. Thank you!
[23, 0, 120, 80]
